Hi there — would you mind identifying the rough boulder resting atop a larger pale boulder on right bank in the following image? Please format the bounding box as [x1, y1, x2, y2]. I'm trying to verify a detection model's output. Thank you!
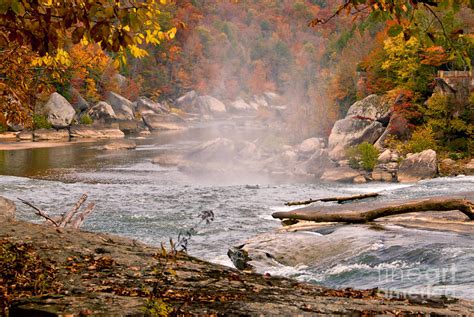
[346, 95, 390, 120]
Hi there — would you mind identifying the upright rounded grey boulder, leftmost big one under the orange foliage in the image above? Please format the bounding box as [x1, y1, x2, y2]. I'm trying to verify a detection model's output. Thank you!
[41, 92, 76, 129]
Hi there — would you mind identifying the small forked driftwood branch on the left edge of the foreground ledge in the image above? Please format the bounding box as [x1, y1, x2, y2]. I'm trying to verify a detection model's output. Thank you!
[18, 194, 95, 229]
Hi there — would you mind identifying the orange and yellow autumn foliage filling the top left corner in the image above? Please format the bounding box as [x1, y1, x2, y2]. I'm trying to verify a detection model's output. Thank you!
[0, 0, 176, 126]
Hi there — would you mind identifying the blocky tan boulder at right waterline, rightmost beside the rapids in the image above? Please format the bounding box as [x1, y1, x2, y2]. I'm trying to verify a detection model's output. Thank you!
[398, 150, 438, 183]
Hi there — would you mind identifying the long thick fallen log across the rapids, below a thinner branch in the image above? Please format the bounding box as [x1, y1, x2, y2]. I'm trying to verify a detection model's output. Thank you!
[272, 198, 474, 223]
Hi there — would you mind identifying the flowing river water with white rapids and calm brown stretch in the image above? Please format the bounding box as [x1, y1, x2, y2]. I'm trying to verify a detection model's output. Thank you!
[0, 124, 474, 299]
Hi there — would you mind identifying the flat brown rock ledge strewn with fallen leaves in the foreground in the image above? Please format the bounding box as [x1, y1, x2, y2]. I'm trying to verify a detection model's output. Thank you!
[0, 221, 474, 316]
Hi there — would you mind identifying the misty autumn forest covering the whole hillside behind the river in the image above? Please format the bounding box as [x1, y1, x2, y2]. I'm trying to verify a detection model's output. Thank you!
[0, 0, 474, 152]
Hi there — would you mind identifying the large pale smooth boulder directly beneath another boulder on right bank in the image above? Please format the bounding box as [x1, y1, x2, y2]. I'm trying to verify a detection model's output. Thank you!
[328, 117, 385, 160]
